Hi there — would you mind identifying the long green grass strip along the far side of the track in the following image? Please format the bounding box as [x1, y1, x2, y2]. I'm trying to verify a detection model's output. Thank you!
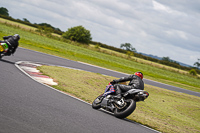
[0, 20, 200, 92]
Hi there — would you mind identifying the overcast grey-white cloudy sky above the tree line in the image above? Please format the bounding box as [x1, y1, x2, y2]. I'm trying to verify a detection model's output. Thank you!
[0, 0, 200, 66]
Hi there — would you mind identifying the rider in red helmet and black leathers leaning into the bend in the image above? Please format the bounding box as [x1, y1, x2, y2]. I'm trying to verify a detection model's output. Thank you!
[110, 72, 144, 100]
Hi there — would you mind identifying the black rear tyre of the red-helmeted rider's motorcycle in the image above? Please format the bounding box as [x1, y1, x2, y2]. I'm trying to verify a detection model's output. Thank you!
[114, 99, 136, 119]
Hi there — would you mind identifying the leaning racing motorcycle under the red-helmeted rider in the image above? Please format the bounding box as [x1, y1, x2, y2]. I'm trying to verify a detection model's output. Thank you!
[92, 84, 149, 119]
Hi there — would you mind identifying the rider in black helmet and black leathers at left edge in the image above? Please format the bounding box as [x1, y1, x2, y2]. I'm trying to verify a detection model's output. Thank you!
[0, 34, 20, 55]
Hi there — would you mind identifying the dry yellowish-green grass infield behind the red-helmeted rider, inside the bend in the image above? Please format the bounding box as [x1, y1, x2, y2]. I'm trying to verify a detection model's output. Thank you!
[38, 66, 200, 133]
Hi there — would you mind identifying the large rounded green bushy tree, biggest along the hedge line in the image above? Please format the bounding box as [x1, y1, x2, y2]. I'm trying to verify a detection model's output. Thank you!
[62, 26, 92, 44]
